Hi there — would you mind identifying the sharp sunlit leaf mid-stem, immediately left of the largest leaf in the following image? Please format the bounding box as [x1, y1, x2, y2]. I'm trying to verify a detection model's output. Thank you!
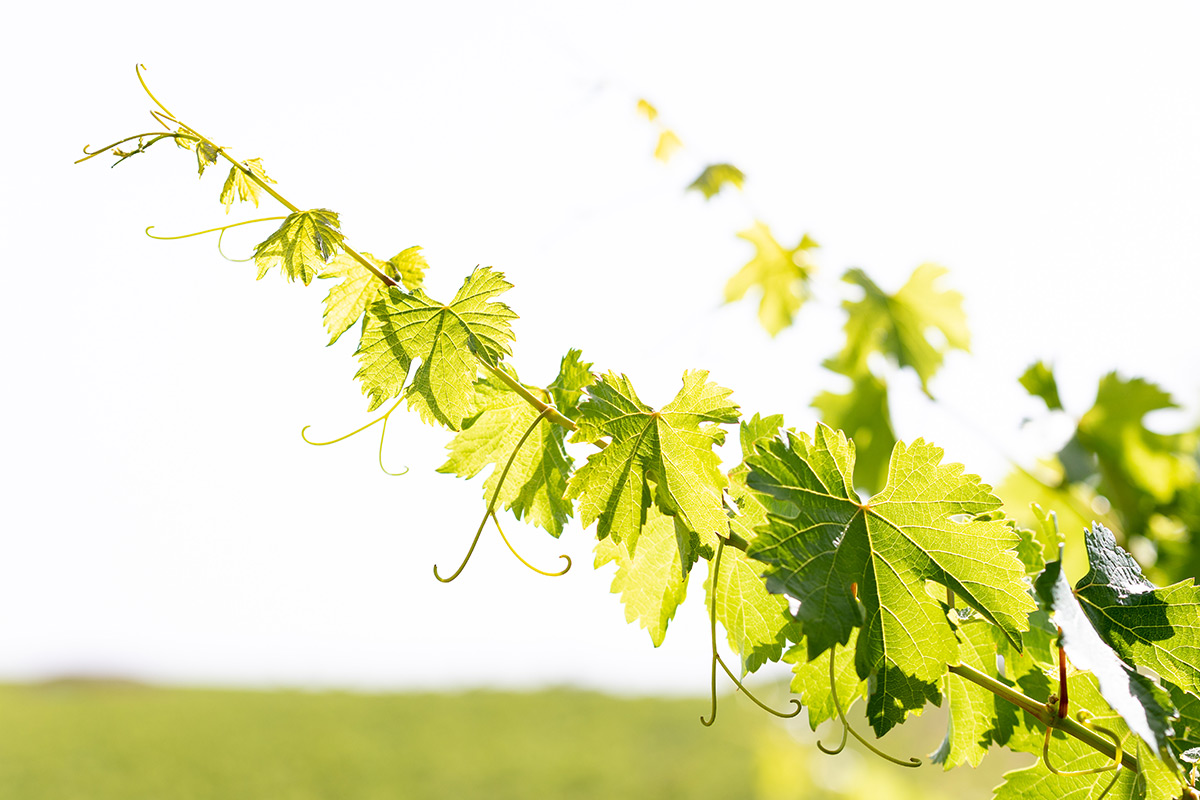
[569, 369, 738, 553]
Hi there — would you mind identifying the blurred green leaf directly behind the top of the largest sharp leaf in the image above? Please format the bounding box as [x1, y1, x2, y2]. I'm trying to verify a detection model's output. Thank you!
[812, 372, 896, 492]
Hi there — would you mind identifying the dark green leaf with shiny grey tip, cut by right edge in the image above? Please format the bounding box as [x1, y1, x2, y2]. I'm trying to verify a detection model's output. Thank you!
[1075, 523, 1200, 693]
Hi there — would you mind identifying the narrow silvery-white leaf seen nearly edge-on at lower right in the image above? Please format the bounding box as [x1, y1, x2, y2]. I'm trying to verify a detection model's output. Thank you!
[1033, 551, 1175, 753]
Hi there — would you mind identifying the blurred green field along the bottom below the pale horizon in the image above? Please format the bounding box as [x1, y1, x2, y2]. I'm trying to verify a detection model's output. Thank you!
[0, 681, 1032, 800]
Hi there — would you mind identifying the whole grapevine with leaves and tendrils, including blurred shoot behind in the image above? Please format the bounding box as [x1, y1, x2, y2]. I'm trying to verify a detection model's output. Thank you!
[79, 65, 1200, 799]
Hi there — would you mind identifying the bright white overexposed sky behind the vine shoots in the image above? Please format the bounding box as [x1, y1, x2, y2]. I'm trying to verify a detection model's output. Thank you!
[0, 2, 1200, 692]
